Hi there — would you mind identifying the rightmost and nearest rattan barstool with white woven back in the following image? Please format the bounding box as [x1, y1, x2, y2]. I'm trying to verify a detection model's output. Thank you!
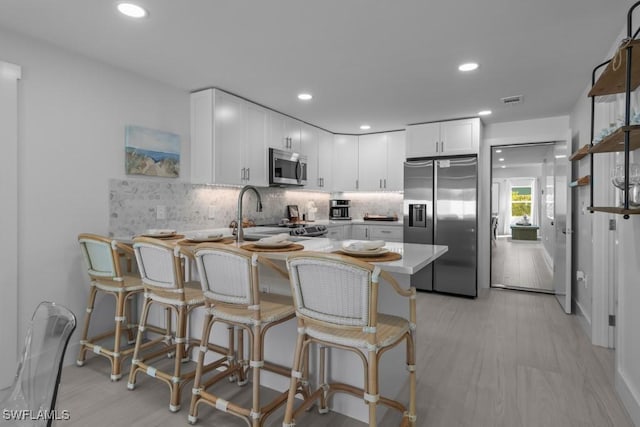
[282, 252, 416, 427]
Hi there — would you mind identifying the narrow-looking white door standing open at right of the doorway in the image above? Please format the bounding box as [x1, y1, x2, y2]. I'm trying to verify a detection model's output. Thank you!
[553, 137, 573, 314]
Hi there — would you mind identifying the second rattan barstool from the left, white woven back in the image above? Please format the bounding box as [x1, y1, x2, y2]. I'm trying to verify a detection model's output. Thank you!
[127, 237, 219, 412]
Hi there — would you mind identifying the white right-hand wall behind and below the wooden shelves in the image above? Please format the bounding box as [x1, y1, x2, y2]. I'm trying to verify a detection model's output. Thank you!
[571, 25, 640, 425]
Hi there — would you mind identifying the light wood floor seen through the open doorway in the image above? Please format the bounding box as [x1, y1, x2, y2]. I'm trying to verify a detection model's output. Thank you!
[491, 236, 553, 291]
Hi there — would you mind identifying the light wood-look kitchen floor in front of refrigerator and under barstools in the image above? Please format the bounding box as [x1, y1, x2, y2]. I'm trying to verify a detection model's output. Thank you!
[57, 289, 633, 427]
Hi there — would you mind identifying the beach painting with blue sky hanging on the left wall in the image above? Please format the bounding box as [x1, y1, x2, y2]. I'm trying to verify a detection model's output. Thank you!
[125, 125, 180, 178]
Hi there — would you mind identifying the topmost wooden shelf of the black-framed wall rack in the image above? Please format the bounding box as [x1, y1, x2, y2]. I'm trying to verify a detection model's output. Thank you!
[589, 40, 640, 96]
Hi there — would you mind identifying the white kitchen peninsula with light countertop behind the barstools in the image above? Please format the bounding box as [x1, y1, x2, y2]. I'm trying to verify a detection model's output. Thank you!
[184, 236, 448, 421]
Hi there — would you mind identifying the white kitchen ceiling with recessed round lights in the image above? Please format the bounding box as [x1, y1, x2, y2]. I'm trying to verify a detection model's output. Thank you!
[0, 0, 633, 133]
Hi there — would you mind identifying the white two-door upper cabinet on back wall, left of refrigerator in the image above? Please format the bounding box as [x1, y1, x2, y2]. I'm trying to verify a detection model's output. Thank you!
[358, 131, 405, 191]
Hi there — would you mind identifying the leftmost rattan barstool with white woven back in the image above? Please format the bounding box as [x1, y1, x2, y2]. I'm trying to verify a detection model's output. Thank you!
[76, 233, 144, 381]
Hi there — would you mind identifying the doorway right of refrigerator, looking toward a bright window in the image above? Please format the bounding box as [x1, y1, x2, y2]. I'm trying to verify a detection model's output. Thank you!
[491, 142, 556, 294]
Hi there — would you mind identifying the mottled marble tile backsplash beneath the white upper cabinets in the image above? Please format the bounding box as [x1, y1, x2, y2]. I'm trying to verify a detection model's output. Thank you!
[109, 179, 402, 236]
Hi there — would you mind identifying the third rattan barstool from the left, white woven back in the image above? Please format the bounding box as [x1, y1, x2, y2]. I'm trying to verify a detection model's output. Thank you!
[189, 243, 308, 427]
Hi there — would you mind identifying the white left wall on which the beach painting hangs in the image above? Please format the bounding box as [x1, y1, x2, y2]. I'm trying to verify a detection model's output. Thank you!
[0, 31, 189, 360]
